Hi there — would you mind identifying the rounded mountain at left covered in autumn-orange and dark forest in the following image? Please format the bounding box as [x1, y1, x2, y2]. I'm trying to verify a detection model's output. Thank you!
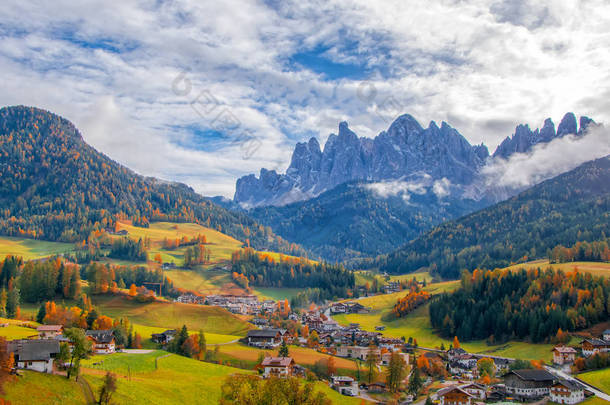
[0, 106, 302, 251]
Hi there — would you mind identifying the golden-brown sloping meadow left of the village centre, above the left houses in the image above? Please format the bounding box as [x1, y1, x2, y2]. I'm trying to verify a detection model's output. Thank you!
[93, 296, 251, 336]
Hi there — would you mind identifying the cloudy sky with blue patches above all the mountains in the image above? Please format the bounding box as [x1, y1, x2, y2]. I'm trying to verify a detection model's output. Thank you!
[0, 0, 610, 197]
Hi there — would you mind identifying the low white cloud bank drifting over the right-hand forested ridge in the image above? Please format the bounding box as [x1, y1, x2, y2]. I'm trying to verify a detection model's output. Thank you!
[482, 127, 610, 188]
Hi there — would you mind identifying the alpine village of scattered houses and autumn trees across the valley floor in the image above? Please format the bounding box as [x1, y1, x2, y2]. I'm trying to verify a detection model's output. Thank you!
[8, 288, 610, 405]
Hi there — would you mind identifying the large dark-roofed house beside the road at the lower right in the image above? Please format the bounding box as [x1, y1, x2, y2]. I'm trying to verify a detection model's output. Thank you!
[504, 369, 555, 400]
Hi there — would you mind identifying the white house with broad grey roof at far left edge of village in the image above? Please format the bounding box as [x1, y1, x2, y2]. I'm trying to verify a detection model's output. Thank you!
[7, 339, 59, 373]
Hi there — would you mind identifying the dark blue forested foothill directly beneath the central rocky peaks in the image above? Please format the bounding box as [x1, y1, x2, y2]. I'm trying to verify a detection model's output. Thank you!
[248, 181, 487, 260]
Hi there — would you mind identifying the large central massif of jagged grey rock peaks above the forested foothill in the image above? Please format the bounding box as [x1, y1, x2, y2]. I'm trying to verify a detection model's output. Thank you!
[234, 114, 489, 208]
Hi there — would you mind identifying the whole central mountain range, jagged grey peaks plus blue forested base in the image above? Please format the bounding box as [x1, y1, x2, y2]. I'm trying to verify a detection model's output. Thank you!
[226, 113, 597, 260]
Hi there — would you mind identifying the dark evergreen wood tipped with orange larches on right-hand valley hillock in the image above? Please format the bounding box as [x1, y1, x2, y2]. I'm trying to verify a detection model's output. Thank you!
[430, 269, 610, 343]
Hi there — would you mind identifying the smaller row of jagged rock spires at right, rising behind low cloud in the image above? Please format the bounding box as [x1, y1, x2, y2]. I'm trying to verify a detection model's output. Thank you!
[493, 113, 595, 159]
